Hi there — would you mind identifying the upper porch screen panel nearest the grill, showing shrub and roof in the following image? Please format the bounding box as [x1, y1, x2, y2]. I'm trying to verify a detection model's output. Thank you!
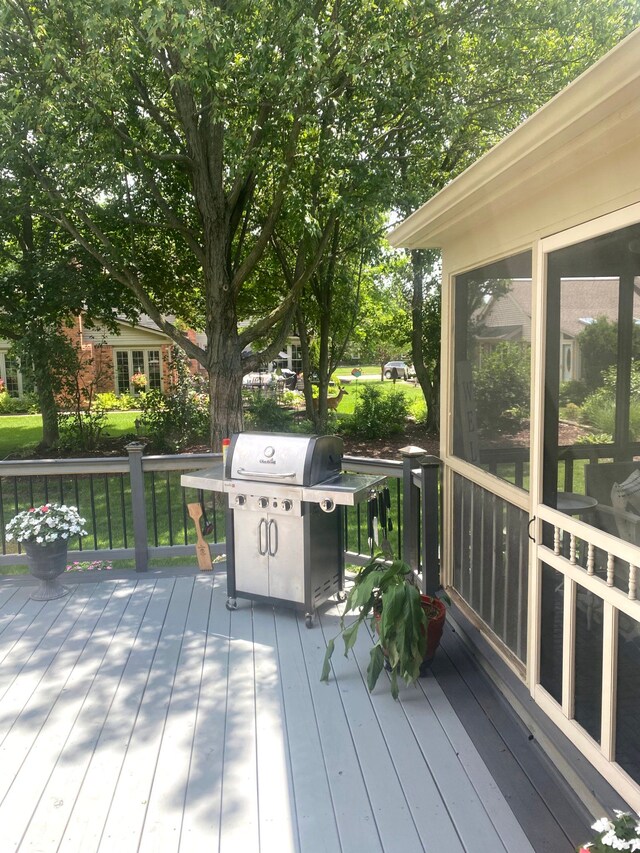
[454, 252, 531, 488]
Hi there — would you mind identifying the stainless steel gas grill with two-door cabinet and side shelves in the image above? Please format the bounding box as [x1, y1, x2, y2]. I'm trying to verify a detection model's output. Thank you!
[181, 432, 385, 627]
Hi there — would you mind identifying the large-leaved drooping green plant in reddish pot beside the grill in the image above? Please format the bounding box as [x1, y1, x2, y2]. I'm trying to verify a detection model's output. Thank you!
[320, 554, 446, 699]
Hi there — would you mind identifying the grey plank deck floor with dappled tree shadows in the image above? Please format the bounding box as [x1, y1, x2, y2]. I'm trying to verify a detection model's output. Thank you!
[0, 573, 588, 853]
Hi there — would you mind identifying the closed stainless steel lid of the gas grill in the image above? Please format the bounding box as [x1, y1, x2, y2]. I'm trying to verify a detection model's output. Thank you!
[225, 432, 343, 486]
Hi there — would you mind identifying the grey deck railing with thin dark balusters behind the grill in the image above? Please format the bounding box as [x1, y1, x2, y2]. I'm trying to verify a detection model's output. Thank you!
[0, 442, 440, 591]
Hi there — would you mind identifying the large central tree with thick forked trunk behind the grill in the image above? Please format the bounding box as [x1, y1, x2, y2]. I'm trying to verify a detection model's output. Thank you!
[0, 0, 422, 445]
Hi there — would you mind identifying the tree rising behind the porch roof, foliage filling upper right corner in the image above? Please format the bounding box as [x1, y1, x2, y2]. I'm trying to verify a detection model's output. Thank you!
[385, 0, 640, 430]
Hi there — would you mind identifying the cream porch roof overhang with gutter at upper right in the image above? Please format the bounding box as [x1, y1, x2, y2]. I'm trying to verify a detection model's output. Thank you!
[389, 28, 640, 253]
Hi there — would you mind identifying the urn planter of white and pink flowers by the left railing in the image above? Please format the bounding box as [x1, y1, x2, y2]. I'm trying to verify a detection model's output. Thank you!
[5, 503, 87, 601]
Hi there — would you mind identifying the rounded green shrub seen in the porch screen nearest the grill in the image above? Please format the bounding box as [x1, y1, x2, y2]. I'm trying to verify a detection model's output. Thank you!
[474, 342, 531, 432]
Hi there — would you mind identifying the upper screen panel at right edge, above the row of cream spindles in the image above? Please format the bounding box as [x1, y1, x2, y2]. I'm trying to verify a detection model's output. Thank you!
[543, 220, 640, 528]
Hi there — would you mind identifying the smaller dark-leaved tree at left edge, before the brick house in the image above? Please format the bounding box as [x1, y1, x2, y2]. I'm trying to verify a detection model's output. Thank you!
[0, 168, 136, 448]
